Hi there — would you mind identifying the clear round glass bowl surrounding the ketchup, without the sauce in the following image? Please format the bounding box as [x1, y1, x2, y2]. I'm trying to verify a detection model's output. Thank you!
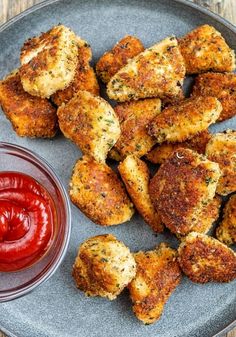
[0, 142, 71, 302]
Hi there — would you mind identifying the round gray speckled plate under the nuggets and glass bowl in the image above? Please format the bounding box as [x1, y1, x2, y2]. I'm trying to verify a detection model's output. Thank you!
[0, 0, 236, 337]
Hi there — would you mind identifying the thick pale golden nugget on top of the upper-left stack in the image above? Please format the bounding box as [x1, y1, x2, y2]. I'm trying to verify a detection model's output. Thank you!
[20, 25, 78, 97]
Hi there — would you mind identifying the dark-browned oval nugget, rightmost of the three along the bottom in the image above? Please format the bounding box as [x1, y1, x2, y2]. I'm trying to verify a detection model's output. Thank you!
[178, 232, 236, 283]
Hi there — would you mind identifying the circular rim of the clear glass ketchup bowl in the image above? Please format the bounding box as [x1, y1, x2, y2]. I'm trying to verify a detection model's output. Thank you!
[0, 141, 71, 303]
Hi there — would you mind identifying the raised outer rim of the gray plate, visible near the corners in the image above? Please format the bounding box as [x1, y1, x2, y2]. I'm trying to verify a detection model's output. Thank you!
[0, 0, 236, 337]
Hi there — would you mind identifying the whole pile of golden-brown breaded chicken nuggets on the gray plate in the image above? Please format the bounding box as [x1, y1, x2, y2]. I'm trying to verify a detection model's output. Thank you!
[0, 25, 236, 324]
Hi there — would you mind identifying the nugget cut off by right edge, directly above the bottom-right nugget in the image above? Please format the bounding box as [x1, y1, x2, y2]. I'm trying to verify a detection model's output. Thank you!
[216, 195, 236, 245]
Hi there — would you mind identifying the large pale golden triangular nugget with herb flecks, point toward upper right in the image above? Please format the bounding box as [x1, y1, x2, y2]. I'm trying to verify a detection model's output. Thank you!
[107, 37, 185, 102]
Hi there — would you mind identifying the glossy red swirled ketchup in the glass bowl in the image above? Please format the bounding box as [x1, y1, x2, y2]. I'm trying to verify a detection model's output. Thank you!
[0, 171, 56, 271]
